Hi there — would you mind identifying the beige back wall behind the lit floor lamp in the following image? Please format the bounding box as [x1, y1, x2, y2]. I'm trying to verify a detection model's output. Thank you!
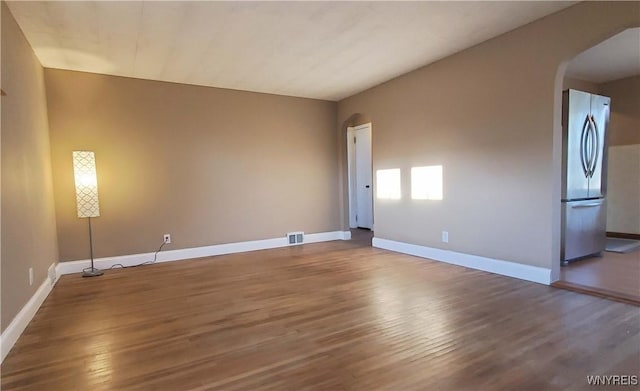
[45, 69, 340, 261]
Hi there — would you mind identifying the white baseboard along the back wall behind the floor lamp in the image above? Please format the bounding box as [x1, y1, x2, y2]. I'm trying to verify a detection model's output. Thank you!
[56, 231, 351, 275]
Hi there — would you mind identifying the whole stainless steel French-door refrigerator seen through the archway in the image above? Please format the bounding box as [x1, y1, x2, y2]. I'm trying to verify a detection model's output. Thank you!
[561, 90, 611, 264]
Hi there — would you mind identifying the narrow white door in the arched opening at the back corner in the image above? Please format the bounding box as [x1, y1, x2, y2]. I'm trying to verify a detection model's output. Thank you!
[355, 125, 373, 229]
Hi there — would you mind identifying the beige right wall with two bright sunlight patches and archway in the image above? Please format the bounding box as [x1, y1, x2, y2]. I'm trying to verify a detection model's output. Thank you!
[337, 2, 640, 272]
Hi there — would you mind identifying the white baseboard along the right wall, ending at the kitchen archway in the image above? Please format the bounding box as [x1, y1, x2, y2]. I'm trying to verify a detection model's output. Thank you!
[372, 238, 551, 285]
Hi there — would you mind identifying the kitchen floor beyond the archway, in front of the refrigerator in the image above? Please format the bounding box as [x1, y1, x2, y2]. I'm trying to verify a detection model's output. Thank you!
[554, 250, 640, 305]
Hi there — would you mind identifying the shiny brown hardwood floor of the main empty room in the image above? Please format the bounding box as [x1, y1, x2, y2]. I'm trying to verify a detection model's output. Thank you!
[1, 240, 640, 391]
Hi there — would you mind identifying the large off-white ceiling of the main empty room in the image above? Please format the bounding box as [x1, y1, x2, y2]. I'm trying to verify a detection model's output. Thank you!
[7, 1, 573, 100]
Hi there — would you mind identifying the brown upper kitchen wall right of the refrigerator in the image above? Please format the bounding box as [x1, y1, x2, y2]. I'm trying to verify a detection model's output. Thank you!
[600, 75, 640, 146]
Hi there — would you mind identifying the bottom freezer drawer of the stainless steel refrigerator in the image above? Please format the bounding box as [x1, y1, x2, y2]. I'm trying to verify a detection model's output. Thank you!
[562, 199, 607, 261]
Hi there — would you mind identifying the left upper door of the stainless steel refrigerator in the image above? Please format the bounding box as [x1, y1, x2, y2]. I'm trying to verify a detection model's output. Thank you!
[562, 90, 592, 200]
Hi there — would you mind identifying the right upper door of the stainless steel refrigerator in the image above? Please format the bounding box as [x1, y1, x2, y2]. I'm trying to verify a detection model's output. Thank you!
[587, 95, 611, 198]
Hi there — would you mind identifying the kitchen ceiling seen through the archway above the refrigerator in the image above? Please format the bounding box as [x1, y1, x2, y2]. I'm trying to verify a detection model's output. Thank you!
[566, 28, 640, 83]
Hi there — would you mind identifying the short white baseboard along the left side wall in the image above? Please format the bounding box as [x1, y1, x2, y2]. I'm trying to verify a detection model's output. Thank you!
[0, 264, 57, 363]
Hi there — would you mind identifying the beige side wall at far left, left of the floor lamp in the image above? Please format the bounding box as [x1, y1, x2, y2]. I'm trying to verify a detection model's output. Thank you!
[1, 2, 58, 331]
